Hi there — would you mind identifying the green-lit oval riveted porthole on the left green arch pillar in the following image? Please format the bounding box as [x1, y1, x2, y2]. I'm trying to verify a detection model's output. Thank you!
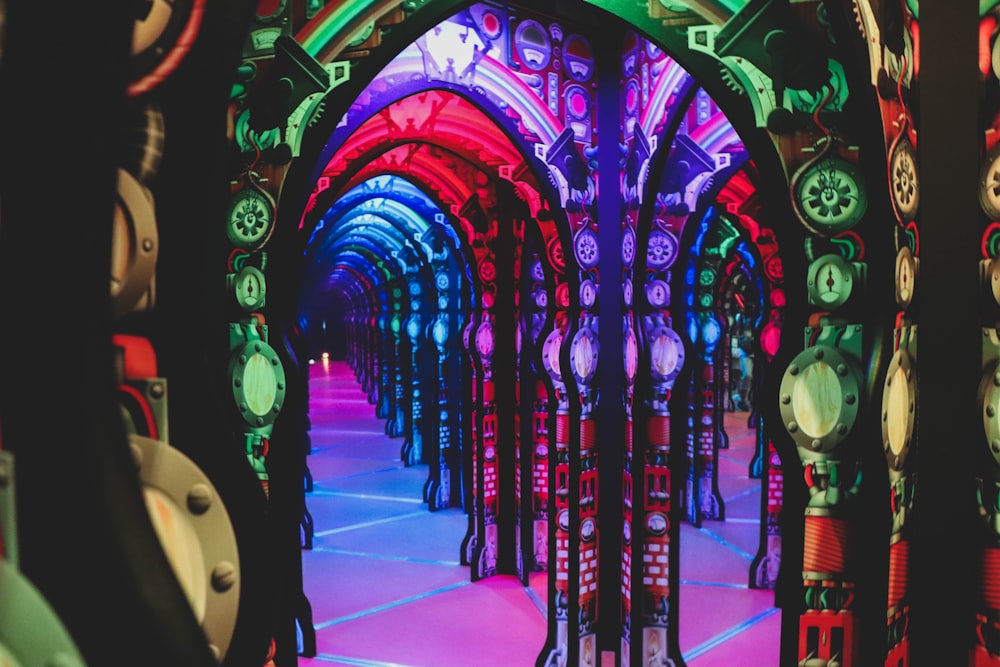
[229, 340, 285, 428]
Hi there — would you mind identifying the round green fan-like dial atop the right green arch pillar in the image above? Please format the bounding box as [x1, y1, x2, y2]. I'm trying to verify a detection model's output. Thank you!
[792, 157, 868, 235]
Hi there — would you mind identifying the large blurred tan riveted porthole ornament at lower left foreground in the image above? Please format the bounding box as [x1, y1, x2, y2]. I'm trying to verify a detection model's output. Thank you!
[130, 434, 240, 664]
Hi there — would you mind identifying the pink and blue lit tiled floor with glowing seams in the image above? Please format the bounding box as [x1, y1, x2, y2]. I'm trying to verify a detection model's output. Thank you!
[299, 361, 780, 667]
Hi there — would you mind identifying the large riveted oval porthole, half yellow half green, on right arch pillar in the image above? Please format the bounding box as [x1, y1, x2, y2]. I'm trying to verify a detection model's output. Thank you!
[778, 345, 861, 454]
